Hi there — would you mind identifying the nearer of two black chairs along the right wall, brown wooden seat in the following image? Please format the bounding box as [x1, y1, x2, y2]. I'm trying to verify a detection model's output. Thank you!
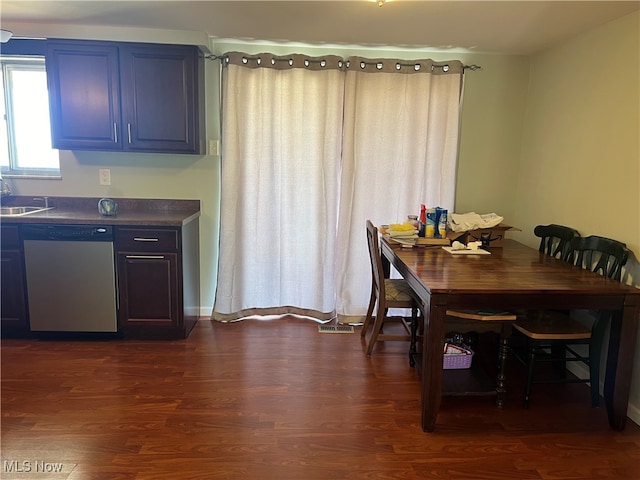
[514, 236, 629, 408]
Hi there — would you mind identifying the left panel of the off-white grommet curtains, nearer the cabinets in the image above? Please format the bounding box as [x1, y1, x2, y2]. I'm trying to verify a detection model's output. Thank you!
[213, 53, 344, 320]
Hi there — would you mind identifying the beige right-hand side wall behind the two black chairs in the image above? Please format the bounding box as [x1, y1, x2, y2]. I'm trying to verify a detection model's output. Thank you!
[513, 12, 640, 423]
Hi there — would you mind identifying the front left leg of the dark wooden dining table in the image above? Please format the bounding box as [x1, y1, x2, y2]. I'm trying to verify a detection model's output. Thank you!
[422, 298, 447, 432]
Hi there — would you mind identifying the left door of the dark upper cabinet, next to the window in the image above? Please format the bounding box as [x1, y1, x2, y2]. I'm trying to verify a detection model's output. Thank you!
[46, 41, 122, 150]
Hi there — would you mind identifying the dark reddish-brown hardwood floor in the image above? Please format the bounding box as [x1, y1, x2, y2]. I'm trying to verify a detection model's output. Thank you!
[0, 318, 640, 480]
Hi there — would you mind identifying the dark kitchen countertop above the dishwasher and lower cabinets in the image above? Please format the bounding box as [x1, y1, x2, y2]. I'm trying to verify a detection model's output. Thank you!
[0, 195, 200, 227]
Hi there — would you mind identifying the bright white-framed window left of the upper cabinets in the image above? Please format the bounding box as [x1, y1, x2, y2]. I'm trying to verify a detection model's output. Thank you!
[0, 57, 60, 177]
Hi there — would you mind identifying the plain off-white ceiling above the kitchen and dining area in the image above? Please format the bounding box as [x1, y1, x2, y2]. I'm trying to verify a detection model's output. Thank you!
[0, 0, 640, 54]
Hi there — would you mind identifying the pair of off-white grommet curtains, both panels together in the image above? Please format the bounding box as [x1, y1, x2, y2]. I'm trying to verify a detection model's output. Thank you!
[213, 52, 462, 321]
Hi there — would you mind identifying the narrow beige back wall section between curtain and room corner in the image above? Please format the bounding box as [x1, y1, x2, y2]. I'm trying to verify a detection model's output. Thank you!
[455, 55, 529, 218]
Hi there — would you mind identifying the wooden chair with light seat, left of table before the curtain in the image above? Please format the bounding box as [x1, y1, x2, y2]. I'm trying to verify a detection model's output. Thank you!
[360, 220, 419, 366]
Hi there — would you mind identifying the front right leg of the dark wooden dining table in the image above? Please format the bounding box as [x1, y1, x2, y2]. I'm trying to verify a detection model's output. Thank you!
[604, 302, 640, 430]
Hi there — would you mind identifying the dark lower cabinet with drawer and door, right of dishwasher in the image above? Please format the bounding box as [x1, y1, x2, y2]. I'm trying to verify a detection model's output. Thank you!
[116, 223, 199, 338]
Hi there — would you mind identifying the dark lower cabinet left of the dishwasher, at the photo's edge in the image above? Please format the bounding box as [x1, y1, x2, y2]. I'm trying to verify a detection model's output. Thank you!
[0, 225, 29, 336]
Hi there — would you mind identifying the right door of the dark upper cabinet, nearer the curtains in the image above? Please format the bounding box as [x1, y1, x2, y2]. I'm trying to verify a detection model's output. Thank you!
[120, 45, 204, 153]
